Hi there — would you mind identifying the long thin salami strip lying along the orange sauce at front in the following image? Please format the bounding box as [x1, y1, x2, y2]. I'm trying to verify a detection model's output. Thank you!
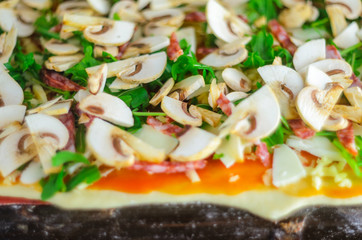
[128, 160, 207, 173]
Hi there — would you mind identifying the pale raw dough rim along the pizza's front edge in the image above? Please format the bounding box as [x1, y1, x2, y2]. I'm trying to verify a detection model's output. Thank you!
[0, 185, 362, 221]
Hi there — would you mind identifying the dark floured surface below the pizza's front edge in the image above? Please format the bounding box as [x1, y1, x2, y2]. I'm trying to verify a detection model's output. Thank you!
[0, 203, 362, 240]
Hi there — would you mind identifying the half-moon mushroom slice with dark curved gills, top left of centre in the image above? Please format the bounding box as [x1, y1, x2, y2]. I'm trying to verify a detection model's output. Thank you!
[83, 21, 135, 46]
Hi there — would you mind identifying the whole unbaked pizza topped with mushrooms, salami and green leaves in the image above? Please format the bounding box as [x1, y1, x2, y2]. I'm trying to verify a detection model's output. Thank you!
[0, 0, 362, 219]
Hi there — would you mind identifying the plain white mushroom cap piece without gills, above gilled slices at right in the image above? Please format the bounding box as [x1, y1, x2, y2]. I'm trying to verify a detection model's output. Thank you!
[293, 38, 326, 72]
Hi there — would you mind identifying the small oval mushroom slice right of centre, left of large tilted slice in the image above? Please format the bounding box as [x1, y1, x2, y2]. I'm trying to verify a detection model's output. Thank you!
[222, 68, 251, 92]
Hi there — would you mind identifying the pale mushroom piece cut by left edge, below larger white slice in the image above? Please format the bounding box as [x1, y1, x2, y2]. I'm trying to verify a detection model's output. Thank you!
[0, 105, 26, 129]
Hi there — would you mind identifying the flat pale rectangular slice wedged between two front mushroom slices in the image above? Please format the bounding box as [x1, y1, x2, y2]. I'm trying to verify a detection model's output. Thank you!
[134, 124, 178, 154]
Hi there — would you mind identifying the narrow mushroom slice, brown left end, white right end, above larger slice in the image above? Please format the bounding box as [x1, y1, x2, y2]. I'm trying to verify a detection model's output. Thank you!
[122, 36, 170, 59]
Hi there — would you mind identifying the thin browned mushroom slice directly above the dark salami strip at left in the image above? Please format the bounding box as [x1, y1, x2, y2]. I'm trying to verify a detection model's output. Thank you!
[44, 53, 84, 72]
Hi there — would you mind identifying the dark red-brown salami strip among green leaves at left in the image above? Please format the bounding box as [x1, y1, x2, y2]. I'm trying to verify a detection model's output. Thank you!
[40, 69, 85, 92]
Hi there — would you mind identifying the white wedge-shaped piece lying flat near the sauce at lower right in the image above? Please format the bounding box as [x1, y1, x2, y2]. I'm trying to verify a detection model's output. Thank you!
[272, 144, 306, 187]
